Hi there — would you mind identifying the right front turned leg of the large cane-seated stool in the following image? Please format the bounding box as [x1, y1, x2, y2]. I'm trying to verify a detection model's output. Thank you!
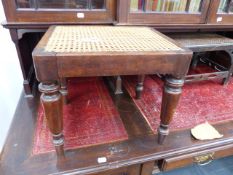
[158, 77, 184, 144]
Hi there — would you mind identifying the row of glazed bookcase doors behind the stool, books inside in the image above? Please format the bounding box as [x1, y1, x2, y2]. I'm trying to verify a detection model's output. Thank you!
[2, 0, 233, 25]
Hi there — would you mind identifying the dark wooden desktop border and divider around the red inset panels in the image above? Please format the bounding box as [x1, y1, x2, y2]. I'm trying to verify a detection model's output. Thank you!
[0, 86, 233, 175]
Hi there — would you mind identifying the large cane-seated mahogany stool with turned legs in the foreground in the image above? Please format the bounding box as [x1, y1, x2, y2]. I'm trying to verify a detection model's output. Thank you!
[33, 26, 192, 155]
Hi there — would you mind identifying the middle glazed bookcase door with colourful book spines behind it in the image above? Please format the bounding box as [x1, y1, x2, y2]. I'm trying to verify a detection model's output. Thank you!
[119, 0, 210, 24]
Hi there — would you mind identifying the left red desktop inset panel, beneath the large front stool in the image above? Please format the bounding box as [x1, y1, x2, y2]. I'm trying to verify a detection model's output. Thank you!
[32, 78, 128, 155]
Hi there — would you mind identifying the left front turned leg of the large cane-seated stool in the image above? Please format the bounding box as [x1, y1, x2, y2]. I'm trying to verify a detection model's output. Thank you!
[39, 82, 64, 156]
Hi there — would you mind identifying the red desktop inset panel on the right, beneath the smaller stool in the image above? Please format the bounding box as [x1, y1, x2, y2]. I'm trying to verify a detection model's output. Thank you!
[124, 67, 233, 133]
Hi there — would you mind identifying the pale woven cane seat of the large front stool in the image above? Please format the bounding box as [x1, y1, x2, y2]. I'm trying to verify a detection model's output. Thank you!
[42, 26, 183, 53]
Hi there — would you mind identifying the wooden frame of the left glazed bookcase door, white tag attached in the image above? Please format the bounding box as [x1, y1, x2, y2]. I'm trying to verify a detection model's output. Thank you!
[0, 0, 116, 23]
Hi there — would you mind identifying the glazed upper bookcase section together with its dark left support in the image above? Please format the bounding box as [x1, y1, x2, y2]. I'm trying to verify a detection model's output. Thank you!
[2, 0, 233, 96]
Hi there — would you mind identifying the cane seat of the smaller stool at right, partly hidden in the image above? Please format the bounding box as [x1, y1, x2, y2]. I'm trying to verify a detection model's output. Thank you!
[169, 34, 233, 48]
